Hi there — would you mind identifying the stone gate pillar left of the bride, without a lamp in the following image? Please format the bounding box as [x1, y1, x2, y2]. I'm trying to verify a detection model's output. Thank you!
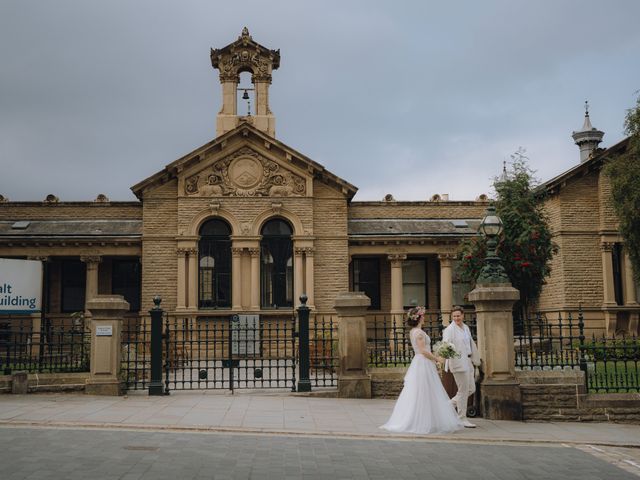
[334, 292, 371, 398]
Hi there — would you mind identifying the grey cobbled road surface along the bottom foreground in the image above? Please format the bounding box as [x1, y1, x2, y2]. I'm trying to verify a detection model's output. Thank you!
[0, 427, 637, 480]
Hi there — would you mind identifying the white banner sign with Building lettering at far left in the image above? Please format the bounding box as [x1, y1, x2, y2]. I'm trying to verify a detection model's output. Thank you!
[0, 258, 42, 314]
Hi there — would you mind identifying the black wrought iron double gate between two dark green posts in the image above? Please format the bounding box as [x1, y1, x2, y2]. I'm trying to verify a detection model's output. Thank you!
[163, 314, 296, 393]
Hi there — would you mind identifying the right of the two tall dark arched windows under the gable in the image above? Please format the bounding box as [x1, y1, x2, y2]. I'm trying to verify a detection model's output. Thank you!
[260, 219, 293, 308]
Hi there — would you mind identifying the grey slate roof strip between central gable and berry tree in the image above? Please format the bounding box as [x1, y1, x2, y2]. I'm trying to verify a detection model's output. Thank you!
[348, 218, 481, 238]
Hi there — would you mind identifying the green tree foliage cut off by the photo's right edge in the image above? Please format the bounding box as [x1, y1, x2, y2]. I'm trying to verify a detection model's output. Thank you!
[604, 96, 640, 282]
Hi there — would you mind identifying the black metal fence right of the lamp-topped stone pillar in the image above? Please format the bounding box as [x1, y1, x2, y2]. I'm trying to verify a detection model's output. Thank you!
[515, 311, 640, 393]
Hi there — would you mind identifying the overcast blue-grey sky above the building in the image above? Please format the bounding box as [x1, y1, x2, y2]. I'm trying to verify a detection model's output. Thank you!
[0, 0, 640, 201]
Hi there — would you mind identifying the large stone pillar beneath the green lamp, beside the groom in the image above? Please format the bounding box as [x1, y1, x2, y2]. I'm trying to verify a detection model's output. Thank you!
[469, 283, 522, 420]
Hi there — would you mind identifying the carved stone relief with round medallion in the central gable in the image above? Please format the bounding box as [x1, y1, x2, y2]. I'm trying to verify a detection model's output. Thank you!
[184, 147, 307, 197]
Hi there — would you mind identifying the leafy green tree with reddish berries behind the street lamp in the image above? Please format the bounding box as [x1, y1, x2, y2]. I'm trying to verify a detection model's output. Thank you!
[459, 149, 557, 318]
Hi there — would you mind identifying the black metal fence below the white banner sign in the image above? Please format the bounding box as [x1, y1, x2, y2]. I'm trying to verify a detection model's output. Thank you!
[0, 315, 91, 375]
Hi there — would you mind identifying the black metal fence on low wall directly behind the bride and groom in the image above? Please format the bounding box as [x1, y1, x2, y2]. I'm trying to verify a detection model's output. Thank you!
[367, 313, 477, 367]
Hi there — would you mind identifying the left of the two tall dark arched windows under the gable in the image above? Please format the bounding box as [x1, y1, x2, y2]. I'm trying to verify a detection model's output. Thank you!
[198, 219, 231, 308]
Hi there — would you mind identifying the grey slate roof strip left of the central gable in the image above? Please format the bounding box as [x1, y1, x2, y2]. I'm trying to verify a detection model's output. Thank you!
[0, 220, 142, 239]
